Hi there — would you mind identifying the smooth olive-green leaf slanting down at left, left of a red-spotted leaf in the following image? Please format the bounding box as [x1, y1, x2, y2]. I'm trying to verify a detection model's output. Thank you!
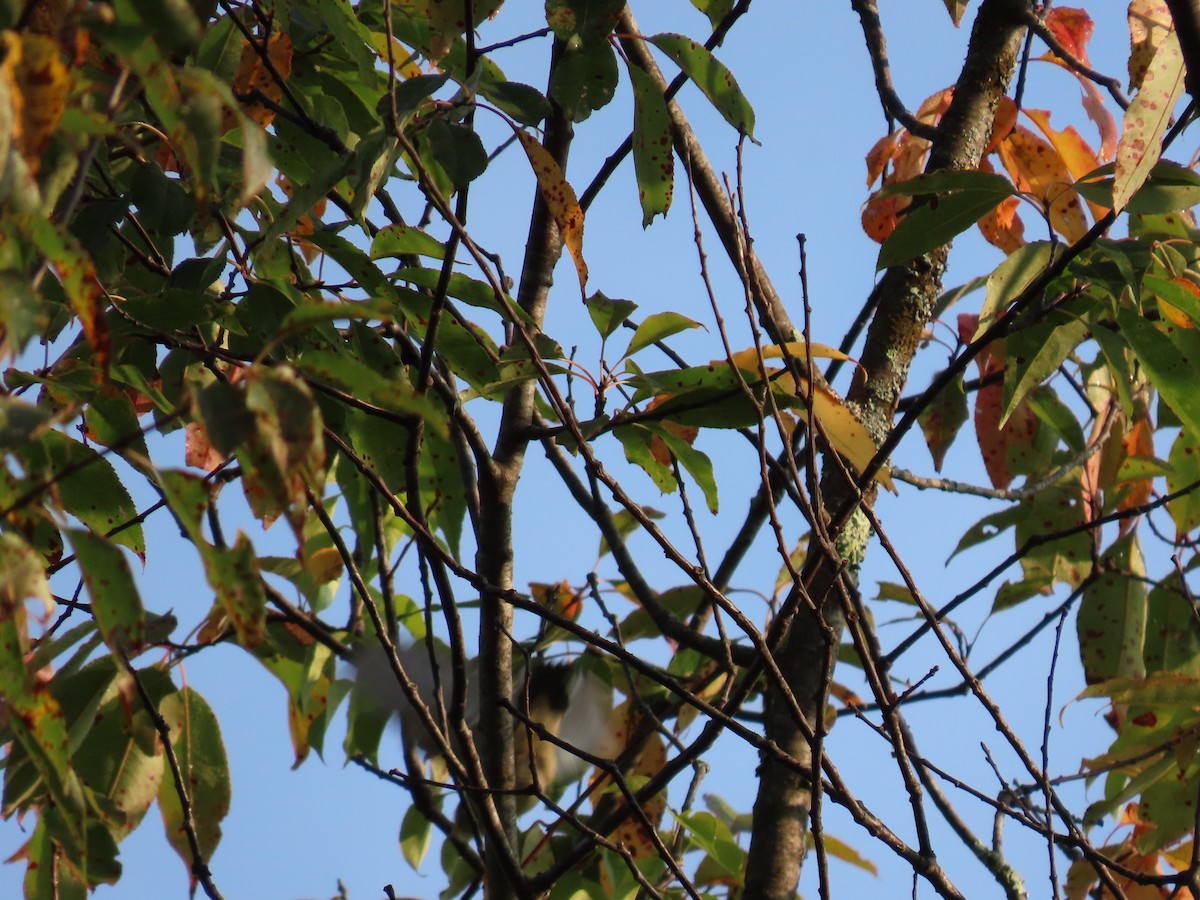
[67, 528, 145, 654]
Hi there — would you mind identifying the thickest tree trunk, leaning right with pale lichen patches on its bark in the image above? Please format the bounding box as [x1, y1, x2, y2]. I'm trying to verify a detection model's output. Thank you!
[744, 0, 1030, 899]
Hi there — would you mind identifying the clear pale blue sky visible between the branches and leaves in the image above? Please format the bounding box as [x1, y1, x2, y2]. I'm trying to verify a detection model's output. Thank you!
[0, 7, 1186, 900]
